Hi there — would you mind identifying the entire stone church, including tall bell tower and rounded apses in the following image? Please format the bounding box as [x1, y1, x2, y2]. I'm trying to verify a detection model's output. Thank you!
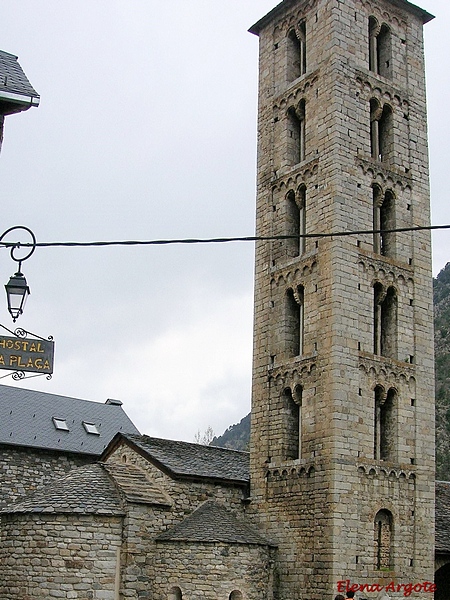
[0, 0, 444, 600]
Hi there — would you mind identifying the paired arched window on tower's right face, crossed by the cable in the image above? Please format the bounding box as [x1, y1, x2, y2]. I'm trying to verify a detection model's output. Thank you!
[372, 184, 395, 258]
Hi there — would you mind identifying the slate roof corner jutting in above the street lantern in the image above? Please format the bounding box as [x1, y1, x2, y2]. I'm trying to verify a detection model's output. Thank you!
[0, 50, 39, 115]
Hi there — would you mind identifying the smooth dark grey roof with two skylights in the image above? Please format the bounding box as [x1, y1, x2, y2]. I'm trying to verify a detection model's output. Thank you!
[0, 385, 139, 456]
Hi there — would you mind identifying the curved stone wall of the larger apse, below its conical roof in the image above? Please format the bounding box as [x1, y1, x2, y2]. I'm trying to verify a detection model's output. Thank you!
[0, 514, 122, 600]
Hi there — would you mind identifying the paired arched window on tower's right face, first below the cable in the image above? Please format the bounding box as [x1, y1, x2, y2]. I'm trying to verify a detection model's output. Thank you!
[373, 282, 397, 359]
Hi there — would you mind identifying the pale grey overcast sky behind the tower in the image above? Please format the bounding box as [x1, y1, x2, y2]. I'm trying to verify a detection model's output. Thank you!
[0, 0, 450, 441]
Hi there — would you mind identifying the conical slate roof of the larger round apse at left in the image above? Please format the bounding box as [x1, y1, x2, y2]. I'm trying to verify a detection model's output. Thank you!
[0, 463, 124, 515]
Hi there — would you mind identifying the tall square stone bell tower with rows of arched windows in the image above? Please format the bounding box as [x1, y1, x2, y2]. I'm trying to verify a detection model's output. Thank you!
[250, 0, 434, 600]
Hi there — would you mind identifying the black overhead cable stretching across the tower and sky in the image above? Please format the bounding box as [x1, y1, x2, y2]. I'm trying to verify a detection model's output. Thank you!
[0, 225, 450, 248]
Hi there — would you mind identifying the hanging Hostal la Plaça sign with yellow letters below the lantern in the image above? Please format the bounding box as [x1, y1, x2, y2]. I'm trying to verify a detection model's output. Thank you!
[0, 336, 55, 375]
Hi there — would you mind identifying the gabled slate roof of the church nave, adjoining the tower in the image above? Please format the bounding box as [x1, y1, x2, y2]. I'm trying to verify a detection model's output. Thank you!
[111, 435, 250, 485]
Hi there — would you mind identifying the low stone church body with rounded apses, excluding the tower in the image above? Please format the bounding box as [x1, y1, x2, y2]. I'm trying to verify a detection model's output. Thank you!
[0, 434, 275, 600]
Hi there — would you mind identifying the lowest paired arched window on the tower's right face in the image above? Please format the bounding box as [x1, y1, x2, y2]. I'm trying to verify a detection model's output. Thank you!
[374, 386, 397, 462]
